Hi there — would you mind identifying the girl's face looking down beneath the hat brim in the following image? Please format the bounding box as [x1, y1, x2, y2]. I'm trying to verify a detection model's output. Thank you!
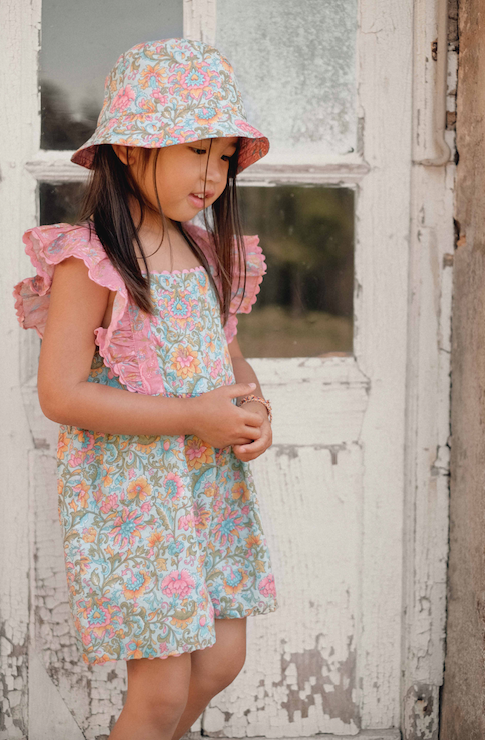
[115, 136, 237, 221]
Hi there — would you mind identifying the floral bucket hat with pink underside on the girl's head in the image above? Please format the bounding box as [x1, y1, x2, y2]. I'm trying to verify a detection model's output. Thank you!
[71, 39, 269, 172]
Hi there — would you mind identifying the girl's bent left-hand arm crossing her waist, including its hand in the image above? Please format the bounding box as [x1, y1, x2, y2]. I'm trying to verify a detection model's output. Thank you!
[38, 257, 261, 447]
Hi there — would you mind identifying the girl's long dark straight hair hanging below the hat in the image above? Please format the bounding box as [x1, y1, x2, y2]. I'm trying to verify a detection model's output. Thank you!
[78, 139, 246, 324]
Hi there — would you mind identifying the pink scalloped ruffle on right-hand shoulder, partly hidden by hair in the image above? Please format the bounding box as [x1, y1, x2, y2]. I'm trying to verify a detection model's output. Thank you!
[183, 222, 267, 343]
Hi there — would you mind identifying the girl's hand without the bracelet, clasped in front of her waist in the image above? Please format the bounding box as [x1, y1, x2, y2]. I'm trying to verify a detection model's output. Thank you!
[190, 383, 263, 447]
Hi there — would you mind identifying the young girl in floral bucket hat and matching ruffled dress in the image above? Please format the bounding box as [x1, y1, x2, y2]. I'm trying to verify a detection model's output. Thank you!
[15, 39, 276, 740]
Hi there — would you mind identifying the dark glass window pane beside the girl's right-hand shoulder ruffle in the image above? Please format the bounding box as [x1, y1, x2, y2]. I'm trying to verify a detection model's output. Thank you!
[238, 185, 354, 357]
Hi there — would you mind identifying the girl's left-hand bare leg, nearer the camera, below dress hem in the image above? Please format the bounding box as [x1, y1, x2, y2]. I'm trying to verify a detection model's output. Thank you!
[109, 653, 191, 740]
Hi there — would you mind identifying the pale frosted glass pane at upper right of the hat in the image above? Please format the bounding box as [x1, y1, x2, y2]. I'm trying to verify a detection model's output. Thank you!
[216, 0, 357, 164]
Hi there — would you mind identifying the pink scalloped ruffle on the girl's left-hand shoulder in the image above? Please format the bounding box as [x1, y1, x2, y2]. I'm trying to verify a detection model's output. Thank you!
[13, 224, 163, 395]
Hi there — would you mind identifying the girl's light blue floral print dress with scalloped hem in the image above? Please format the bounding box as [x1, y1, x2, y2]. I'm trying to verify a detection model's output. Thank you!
[15, 224, 277, 663]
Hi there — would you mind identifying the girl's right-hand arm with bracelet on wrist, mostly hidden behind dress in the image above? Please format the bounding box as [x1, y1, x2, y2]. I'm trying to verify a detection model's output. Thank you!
[229, 337, 273, 462]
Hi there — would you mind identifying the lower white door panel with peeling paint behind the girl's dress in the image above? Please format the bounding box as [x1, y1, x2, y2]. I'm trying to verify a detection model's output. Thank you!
[20, 376, 366, 740]
